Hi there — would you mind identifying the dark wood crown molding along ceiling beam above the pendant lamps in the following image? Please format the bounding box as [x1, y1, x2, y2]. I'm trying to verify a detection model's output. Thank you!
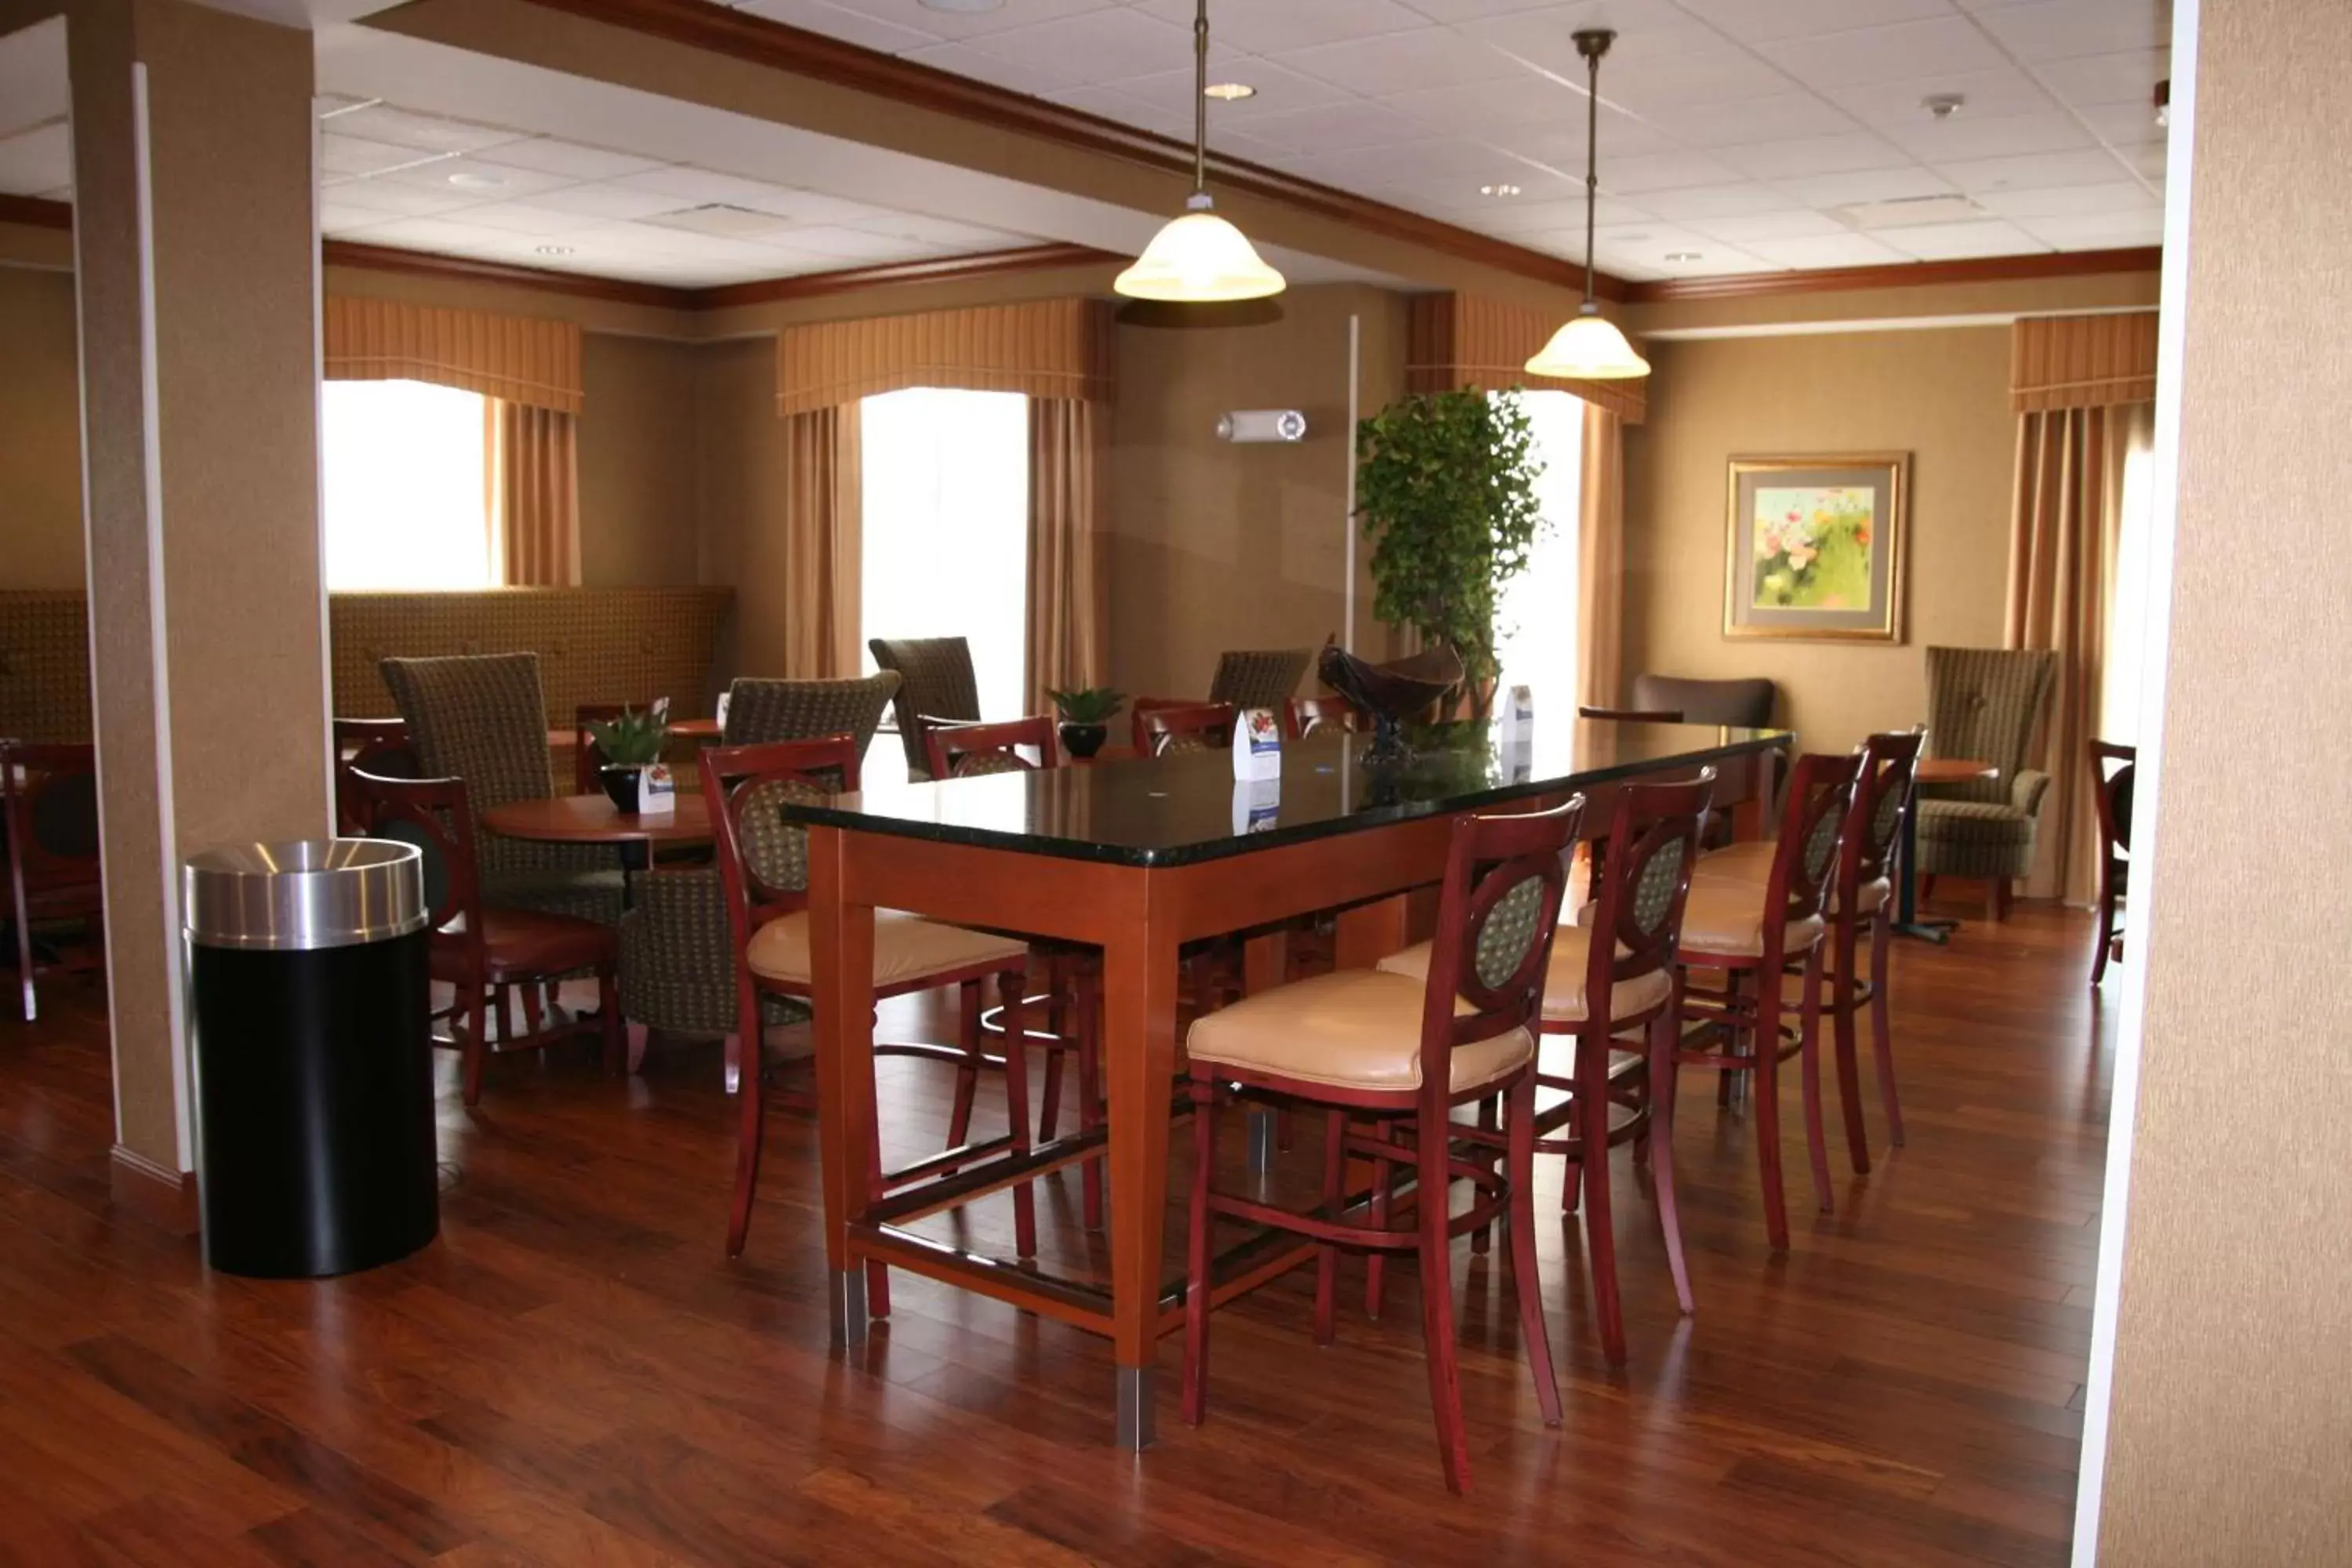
[501, 0, 1625, 299]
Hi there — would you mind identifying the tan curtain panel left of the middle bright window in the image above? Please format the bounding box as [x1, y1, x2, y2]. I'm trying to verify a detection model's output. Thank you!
[783, 402, 866, 680]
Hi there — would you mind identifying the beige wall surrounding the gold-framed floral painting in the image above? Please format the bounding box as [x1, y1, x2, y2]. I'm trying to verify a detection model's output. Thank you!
[1625, 327, 2016, 750]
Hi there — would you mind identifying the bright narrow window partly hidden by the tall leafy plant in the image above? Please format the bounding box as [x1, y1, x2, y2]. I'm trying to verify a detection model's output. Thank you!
[1494, 393, 1585, 720]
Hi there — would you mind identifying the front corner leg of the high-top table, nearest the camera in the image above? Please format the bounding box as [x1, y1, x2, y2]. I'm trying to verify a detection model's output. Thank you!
[1103, 909, 1176, 1448]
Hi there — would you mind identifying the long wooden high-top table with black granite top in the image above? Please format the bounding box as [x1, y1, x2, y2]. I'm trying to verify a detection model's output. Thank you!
[783, 722, 1790, 1448]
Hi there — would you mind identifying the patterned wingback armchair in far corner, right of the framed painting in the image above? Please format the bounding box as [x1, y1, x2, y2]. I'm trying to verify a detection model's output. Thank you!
[1919, 649, 2058, 919]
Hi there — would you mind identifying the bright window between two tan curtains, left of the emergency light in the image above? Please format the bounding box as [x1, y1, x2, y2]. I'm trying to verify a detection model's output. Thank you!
[858, 388, 1028, 720]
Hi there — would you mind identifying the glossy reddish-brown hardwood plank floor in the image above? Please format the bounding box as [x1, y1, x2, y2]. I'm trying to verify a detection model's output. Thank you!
[0, 907, 2114, 1568]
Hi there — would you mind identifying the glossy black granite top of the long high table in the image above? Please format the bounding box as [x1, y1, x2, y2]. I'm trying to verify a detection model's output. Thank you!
[783, 720, 1790, 867]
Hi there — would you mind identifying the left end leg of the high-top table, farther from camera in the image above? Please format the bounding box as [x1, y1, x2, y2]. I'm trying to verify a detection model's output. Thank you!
[809, 827, 875, 1345]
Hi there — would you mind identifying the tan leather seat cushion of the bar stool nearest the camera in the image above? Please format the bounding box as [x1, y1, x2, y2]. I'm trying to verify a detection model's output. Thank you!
[1185, 968, 1536, 1093]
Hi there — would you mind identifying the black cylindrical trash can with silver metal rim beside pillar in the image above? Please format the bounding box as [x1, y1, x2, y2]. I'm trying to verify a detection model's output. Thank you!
[181, 839, 440, 1279]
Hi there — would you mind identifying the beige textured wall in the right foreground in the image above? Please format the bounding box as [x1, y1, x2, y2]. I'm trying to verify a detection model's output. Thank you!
[2093, 0, 2352, 1568]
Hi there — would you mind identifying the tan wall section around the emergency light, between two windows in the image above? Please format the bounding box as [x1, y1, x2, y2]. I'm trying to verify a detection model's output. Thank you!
[1105, 285, 1404, 696]
